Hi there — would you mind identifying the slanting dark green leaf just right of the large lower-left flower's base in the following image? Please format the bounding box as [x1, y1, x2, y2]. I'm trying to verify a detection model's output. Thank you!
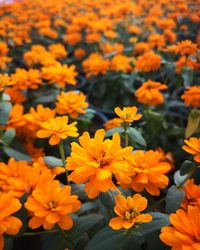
[69, 214, 104, 239]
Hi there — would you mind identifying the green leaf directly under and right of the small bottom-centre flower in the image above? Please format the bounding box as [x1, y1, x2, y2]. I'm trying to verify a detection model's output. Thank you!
[132, 212, 170, 236]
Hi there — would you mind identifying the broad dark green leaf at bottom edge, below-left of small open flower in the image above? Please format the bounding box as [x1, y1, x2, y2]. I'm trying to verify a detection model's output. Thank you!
[85, 226, 128, 250]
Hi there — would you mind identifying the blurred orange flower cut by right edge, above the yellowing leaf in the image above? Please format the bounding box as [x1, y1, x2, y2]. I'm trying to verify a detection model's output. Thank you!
[181, 86, 200, 107]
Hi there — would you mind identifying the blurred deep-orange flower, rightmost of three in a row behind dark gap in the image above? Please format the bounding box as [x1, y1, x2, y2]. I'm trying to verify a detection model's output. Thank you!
[135, 51, 161, 72]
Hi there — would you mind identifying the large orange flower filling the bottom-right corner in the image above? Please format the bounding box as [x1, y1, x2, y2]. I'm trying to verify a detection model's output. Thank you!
[160, 206, 200, 250]
